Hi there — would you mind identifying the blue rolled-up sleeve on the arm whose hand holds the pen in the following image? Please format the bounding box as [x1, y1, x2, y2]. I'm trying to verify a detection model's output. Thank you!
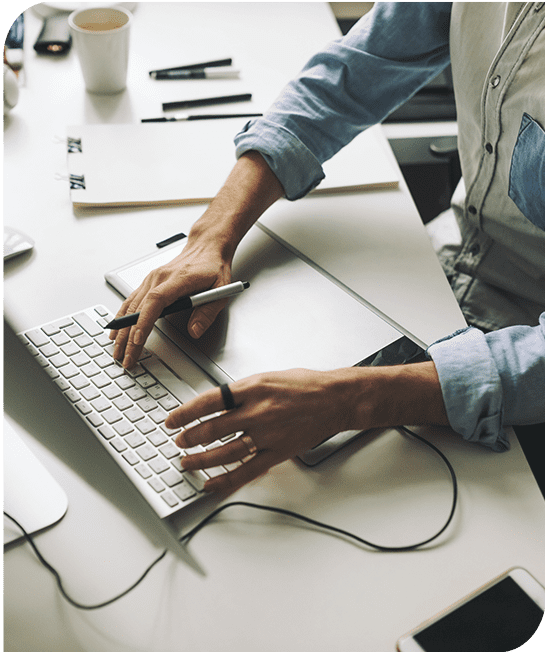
[235, 2, 452, 200]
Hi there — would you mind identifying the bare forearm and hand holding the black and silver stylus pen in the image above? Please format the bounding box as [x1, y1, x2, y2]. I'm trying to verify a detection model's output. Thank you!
[110, 151, 284, 369]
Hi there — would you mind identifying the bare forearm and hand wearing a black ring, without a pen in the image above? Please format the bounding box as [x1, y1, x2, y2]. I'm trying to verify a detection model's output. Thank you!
[169, 362, 448, 492]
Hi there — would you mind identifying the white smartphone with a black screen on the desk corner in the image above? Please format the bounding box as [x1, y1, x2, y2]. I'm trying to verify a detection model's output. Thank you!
[397, 568, 545, 652]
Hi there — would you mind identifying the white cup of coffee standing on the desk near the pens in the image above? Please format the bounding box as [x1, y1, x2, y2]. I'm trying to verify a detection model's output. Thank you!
[68, 7, 132, 95]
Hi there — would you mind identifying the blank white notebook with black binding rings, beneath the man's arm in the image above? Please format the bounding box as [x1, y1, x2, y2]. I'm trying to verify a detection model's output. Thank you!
[67, 118, 399, 208]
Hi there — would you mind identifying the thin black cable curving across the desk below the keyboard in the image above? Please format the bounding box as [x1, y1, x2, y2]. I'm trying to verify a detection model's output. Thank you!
[3, 426, 458, 610]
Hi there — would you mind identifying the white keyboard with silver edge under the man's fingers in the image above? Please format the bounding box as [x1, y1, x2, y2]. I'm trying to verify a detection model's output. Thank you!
[19, 306, 237, 518]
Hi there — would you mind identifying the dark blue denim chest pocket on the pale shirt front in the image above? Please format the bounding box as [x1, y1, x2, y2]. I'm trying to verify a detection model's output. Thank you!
[509, 113, 545, 230]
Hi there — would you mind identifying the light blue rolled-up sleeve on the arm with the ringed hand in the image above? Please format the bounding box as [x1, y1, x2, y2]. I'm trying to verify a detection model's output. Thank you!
[428, 312, 545, 452]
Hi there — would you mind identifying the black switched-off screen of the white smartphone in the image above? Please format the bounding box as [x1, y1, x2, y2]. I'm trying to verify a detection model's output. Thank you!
[414, 577, 543, 652]
